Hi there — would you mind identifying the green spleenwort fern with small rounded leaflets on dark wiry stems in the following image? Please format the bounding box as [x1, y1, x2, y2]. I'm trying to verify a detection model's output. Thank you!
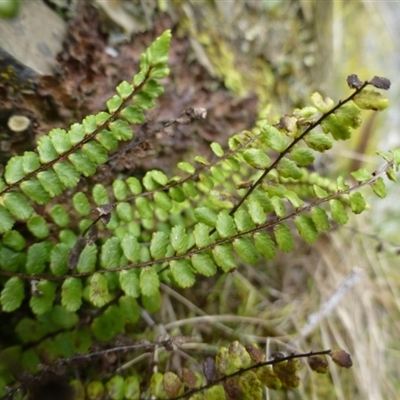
[0, 31, 400, 398]
